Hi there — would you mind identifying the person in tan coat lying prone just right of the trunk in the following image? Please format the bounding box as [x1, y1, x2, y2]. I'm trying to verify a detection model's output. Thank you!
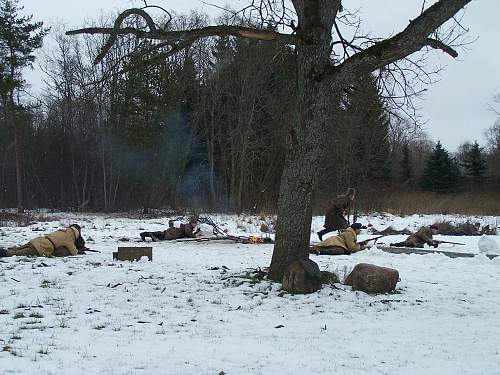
[313, 223, 366, 255]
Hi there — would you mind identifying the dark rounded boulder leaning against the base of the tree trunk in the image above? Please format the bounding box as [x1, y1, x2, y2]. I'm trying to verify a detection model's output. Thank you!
[282, 259, 321, 294]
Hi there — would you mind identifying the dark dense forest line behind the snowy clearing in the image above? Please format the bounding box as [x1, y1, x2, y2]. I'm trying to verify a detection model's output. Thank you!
[0, 0, 500, 212]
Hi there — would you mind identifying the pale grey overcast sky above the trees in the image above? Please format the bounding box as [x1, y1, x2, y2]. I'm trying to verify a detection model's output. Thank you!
[19, 0, 500, 150]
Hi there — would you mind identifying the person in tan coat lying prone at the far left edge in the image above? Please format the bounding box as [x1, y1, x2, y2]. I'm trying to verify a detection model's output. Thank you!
[0, 224, 86, 257]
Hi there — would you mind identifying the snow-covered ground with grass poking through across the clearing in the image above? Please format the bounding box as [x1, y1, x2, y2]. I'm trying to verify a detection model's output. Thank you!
[0, 214, 500, 375]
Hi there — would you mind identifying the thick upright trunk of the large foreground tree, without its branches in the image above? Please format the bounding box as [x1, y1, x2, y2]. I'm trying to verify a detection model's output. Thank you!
[268, 0, 338, 281]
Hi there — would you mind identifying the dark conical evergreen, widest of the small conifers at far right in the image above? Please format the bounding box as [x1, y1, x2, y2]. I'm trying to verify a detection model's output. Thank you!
[421, 141, 460, 193]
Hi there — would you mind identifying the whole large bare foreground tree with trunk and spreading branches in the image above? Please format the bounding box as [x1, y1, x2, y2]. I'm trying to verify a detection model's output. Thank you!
[67, 0, 470, 281]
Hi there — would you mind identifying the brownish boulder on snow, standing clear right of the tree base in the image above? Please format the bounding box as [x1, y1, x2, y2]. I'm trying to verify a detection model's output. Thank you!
[344, 263, 399, 293]
